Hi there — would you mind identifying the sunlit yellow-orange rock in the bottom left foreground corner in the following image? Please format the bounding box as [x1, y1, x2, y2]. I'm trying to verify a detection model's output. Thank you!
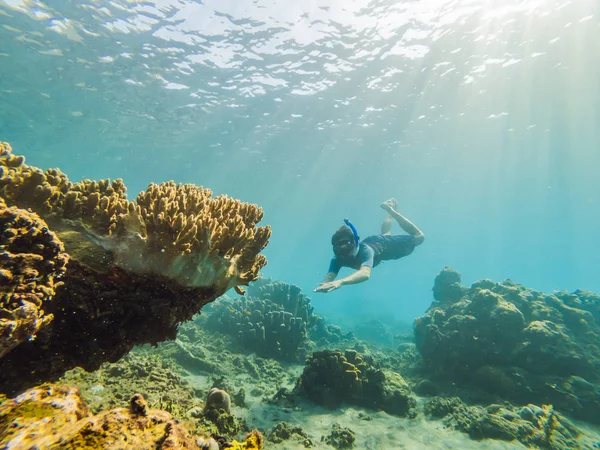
[0, 385, 198, 450]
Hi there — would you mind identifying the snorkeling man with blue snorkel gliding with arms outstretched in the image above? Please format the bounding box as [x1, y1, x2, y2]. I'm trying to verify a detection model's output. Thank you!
[314, 198, 425, 292]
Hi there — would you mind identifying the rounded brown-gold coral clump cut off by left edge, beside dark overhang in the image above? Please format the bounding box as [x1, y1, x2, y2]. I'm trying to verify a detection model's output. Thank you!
[0, 198, 69, 358]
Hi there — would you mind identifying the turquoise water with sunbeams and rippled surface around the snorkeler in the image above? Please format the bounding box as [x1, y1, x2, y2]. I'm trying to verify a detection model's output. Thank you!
[0, 0, 600, 321]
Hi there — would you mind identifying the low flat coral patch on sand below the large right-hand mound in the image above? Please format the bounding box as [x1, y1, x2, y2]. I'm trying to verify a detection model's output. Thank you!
[425, 397, 586, 449]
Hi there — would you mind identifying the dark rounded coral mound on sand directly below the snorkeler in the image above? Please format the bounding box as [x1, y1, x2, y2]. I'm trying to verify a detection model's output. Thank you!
[294, 350, 416, 417]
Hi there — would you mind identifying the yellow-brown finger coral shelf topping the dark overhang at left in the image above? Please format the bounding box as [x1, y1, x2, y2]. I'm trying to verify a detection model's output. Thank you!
[0, 143, 271, 293]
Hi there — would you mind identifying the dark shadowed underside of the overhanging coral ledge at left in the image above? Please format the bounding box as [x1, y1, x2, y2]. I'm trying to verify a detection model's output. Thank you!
[0, 255, 220, 394]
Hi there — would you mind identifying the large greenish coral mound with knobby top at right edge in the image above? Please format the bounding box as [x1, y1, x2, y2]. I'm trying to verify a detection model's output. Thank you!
[414, 268, 600, 423]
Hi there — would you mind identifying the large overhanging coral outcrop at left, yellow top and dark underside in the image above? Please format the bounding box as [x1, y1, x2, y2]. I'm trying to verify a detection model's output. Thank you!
[0, 144, 270, 394]
